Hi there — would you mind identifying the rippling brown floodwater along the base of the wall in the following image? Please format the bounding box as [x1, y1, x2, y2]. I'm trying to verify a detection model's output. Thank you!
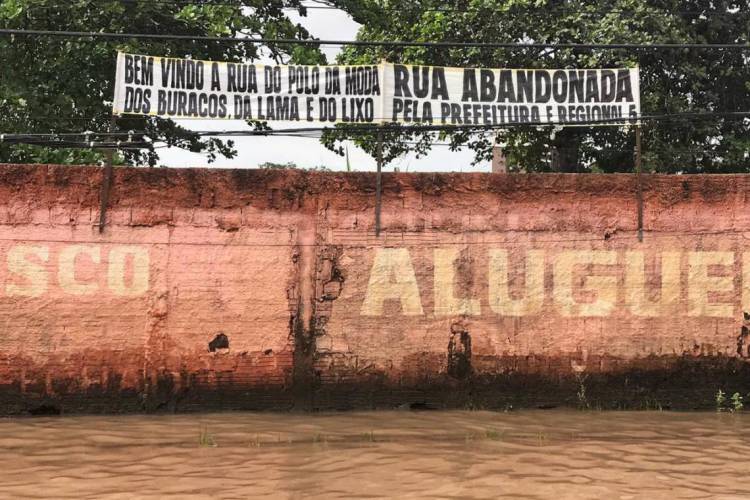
[0, 410, 750, 500]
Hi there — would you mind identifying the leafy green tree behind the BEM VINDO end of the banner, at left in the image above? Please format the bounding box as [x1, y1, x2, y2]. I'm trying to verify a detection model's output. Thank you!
[0, 0, 325, 166]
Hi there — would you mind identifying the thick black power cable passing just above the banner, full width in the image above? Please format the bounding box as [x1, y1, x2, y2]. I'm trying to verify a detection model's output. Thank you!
[0, 28, 750, 51]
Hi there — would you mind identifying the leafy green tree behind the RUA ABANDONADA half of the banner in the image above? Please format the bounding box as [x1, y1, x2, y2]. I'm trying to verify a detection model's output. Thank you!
[324, 0, 750, 172]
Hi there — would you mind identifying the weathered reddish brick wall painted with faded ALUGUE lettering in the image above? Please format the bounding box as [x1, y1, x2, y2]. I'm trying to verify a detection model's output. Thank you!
[0, 165, 750, 413]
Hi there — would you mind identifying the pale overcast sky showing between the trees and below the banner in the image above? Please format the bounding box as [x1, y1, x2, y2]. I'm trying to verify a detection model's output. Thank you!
[160, 5, 490, 172]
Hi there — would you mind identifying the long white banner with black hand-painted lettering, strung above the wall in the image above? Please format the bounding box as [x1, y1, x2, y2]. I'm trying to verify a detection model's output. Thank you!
[113, 53, 640, 126]
